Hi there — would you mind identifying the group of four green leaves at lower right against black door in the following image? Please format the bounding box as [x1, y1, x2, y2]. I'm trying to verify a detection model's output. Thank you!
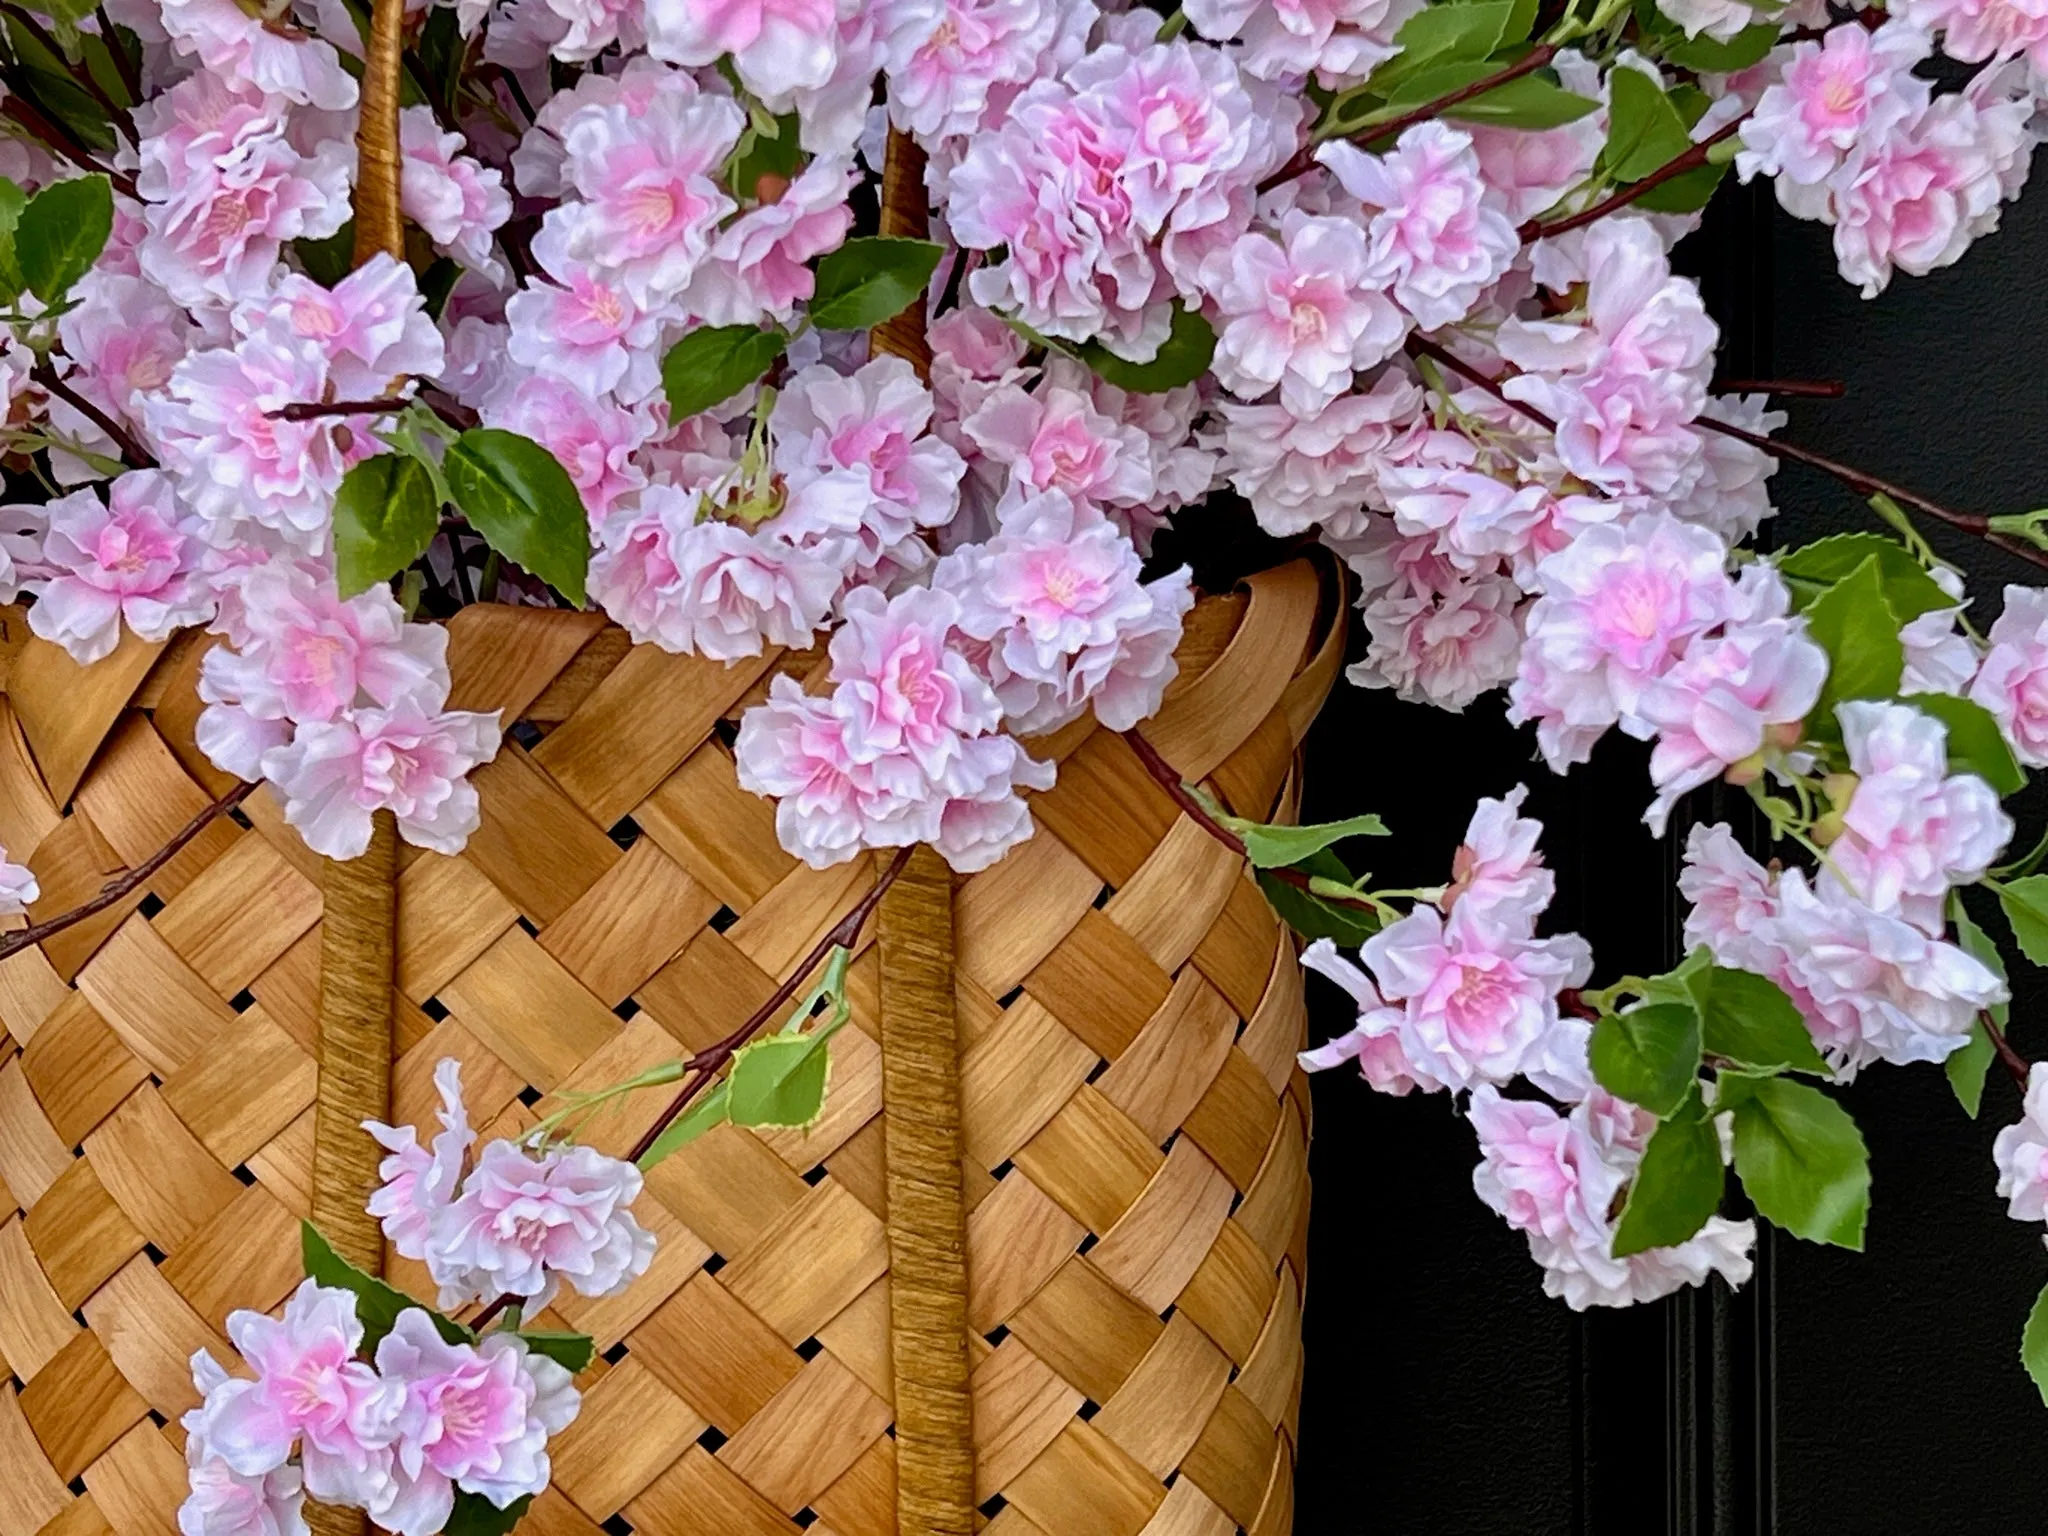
[1589, 950, 1870, 1257]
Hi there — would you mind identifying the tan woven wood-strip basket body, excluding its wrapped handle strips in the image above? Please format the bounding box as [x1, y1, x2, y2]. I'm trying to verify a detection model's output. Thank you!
[0, 565, 1339, 1536]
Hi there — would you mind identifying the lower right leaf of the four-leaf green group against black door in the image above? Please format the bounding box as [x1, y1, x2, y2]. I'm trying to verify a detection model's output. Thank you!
[1720, 1073, 1870, 1251]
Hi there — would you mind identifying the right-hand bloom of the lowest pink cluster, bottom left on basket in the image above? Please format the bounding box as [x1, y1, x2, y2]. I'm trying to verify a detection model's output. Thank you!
[377, 1310, 582, 1536]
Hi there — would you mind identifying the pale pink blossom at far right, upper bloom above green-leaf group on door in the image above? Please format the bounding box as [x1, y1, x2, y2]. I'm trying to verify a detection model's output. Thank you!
[1827, 700, 2013, 934]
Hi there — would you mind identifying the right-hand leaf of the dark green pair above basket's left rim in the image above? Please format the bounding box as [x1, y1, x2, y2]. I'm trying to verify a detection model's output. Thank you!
[440, 426, 590, 608]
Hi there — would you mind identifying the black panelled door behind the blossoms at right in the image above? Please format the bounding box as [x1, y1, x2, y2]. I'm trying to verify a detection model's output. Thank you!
[1296, 174, 2048, 1536]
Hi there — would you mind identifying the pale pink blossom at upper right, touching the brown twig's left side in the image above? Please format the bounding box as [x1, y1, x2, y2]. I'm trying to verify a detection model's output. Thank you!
[1315, 121, 1522, 330]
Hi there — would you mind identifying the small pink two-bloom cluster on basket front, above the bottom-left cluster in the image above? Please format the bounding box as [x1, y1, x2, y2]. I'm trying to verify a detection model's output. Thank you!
[362, 1059, 653, 1315]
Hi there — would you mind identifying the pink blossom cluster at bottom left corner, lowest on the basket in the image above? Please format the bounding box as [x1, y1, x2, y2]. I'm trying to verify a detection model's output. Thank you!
[178, 1280, 580, 1536]
